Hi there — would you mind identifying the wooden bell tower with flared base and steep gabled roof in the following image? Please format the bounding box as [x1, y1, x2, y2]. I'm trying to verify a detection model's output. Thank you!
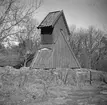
[31, 11, 80, 68]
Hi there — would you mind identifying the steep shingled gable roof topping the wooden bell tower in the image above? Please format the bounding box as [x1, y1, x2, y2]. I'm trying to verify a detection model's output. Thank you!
[38, 10, 70, 34]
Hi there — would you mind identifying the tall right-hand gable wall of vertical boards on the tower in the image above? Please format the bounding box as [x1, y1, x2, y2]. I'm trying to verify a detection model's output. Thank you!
[53, 17, 78, 68]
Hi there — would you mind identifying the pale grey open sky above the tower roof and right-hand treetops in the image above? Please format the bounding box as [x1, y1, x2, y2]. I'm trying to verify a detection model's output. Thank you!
[34, 0, 107, 30]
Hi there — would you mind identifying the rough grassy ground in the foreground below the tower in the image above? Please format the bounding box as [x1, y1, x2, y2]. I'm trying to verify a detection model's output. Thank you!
[0, 67, 107, 105]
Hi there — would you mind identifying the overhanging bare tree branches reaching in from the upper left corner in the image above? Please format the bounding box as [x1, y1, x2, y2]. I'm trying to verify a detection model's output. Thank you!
[0, 0, 42, 42]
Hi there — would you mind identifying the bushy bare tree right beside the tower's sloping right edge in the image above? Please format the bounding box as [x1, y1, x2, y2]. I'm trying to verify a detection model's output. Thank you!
[71, 26, 103, 68]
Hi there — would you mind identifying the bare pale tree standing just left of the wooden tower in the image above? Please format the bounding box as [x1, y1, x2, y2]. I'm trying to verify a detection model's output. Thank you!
[16, 17, 40, 66]
